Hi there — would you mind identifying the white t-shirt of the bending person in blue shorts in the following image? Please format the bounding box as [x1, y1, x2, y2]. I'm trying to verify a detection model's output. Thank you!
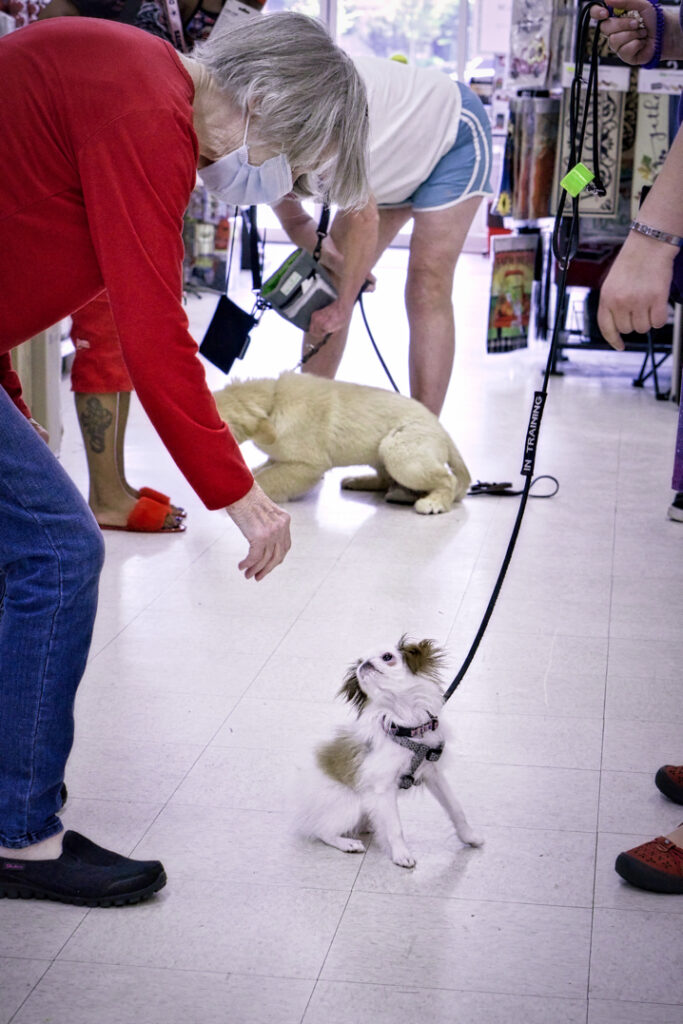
[353, 56, 462, 203]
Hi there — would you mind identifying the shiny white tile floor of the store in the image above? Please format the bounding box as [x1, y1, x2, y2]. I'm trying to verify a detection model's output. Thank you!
[0, 247, 683, 1024]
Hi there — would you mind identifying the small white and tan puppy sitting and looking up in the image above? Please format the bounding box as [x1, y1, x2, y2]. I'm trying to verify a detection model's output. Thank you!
[297, 637, 483, 867]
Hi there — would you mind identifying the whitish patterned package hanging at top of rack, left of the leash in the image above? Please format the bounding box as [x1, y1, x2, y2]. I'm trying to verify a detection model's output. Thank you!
[508, 0, 553, 89]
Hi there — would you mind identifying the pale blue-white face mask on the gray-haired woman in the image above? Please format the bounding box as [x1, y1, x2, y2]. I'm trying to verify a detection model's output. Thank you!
[199, 118, 293, 206]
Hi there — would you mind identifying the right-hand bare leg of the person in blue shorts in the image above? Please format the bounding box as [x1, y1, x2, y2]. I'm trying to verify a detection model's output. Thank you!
[405, 197, 481, 416]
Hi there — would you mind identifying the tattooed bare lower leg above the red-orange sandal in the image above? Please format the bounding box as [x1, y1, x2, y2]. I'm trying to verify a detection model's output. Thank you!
[75, 391, 176, 528]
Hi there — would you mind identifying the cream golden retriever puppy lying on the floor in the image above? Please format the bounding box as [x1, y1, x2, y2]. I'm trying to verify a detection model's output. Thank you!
[214, 372, 470, 515]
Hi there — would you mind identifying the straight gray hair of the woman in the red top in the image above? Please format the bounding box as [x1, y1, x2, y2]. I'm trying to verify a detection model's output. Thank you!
[191, 11, 369, 209]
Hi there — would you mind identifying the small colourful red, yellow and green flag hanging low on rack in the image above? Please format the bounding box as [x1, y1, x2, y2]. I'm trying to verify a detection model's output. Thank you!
[486, 234, 539, 352]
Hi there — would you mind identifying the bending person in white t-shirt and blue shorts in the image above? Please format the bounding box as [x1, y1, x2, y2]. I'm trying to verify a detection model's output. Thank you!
[274, 56, 493, 425]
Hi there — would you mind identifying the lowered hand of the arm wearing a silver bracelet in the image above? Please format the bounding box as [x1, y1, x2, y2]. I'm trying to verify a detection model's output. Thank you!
[598, 232, 677, 350]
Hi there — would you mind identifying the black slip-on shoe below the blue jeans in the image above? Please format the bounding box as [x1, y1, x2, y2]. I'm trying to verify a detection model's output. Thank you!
[0, 831, 166, 906]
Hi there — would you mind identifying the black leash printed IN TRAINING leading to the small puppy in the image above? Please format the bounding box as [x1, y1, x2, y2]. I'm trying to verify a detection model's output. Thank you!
[443, 3, 608, 703]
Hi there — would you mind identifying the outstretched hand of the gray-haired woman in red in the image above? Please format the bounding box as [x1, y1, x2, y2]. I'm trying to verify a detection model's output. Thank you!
[225, 482, 292, 580]
